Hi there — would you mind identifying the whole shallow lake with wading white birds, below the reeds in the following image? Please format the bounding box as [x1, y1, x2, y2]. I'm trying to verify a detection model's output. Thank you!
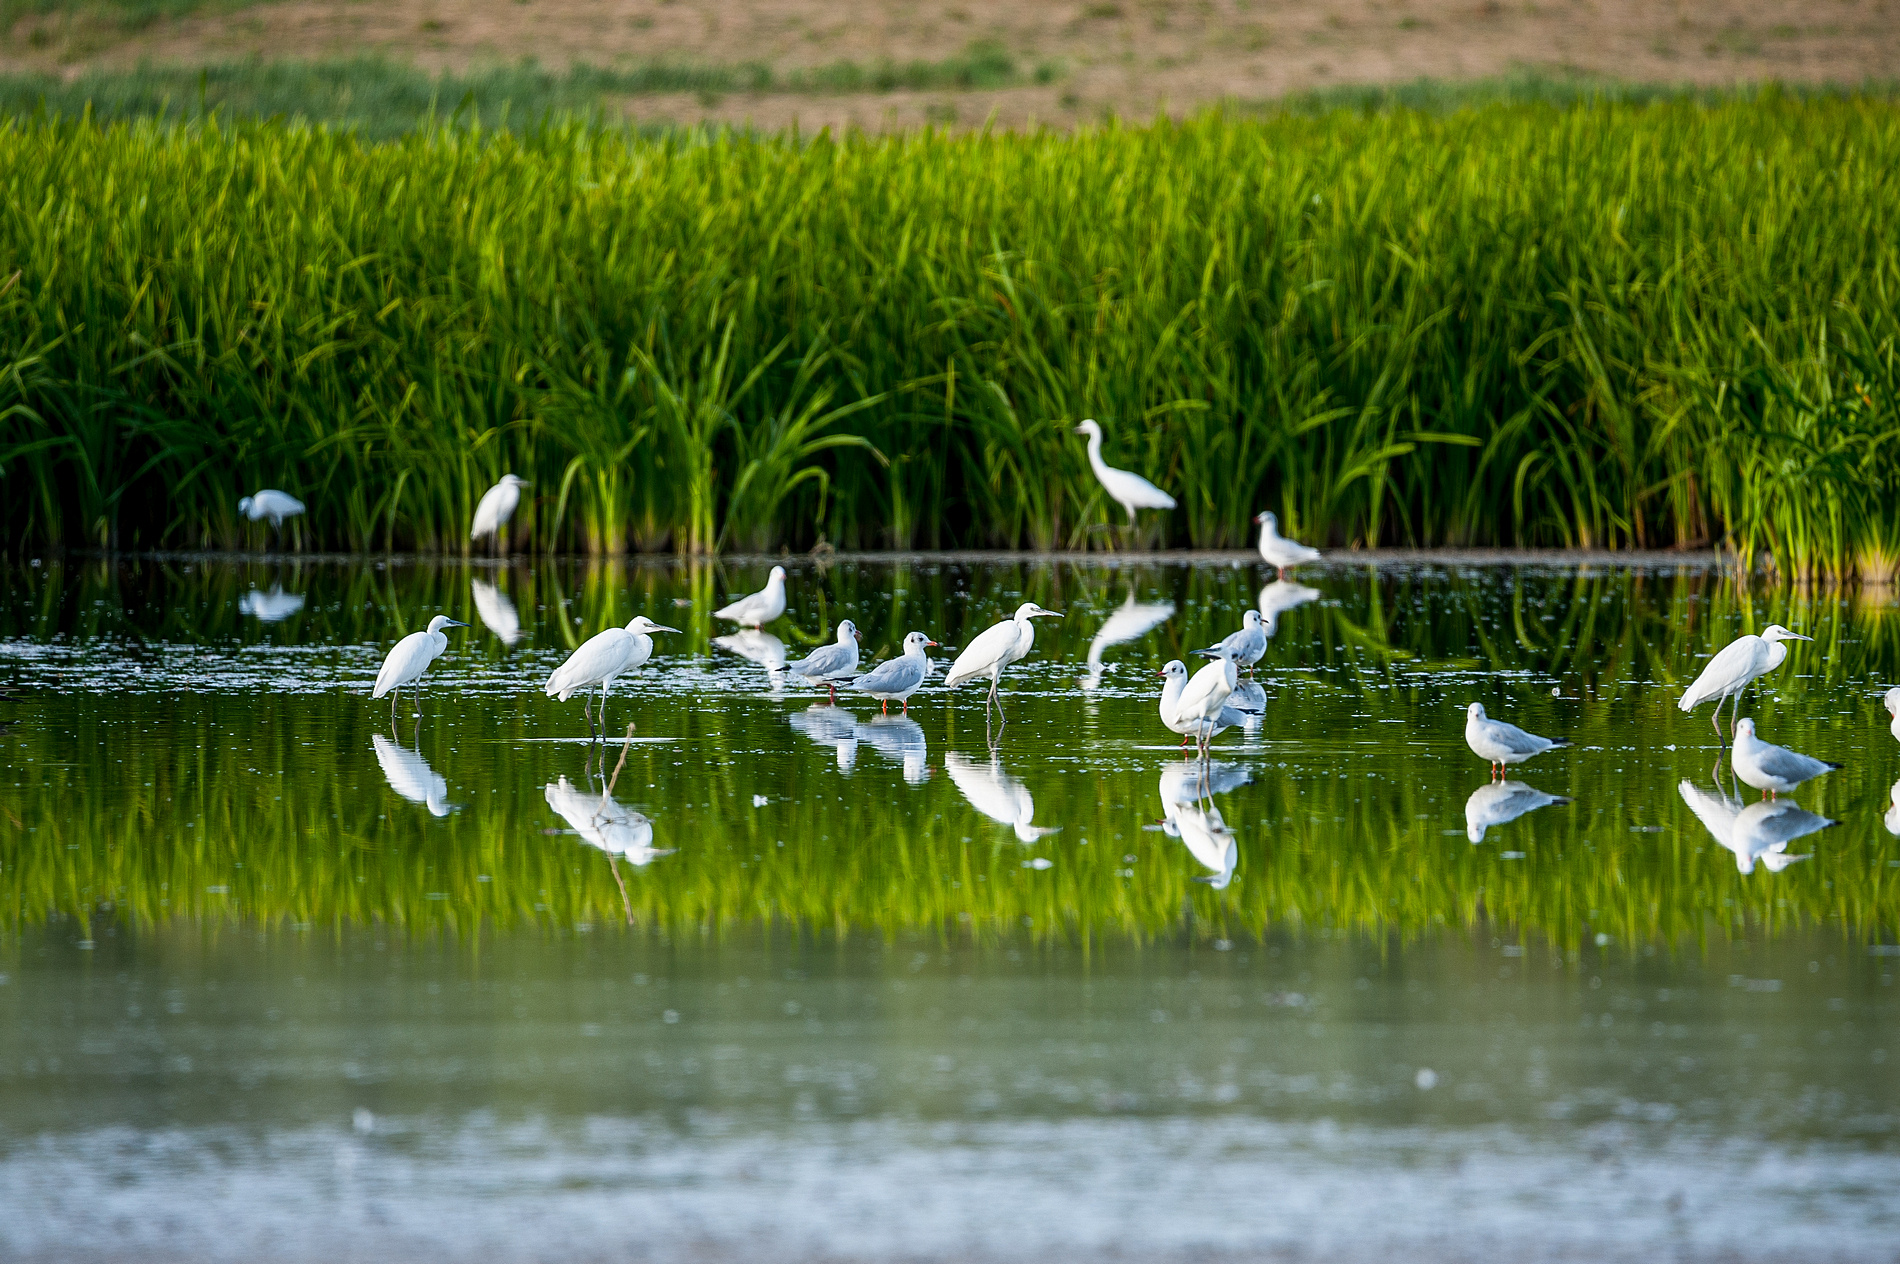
[0, 557, 1900, 1262]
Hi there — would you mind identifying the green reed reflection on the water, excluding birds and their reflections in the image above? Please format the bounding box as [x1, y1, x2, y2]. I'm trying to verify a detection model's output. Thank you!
[0, 559, 1900, 947]
